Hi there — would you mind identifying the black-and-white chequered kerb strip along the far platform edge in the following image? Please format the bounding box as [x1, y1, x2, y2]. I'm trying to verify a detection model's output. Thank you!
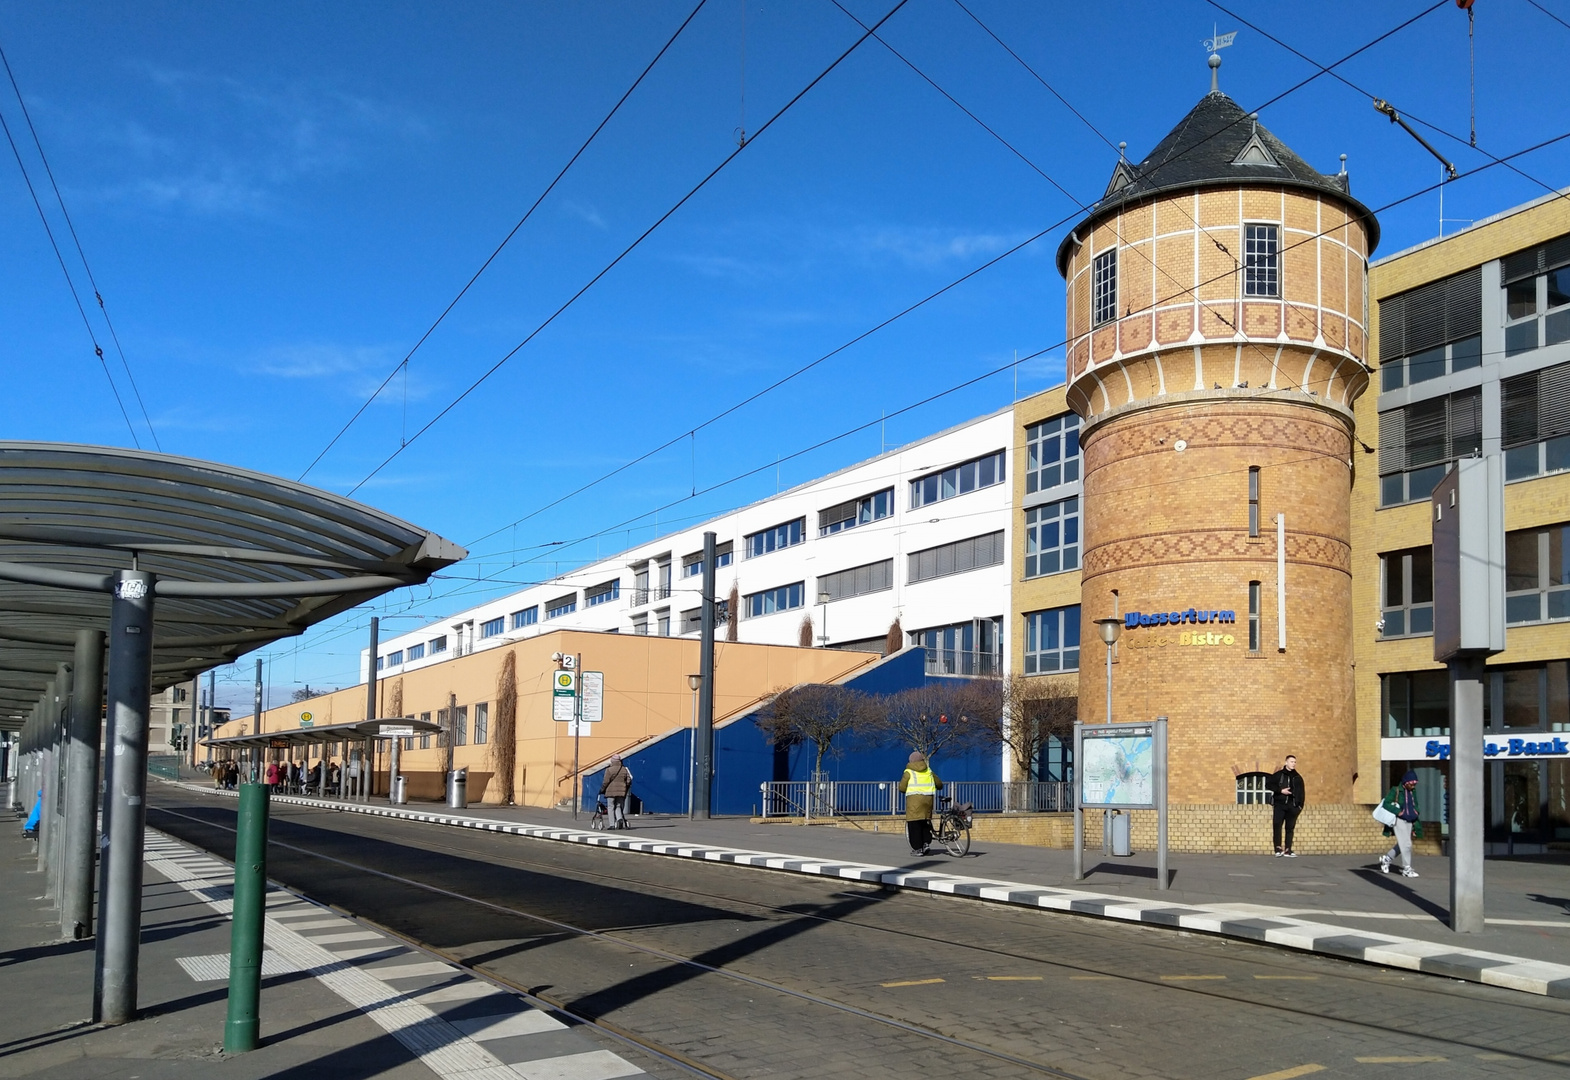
[205, 785, 1570, 1000]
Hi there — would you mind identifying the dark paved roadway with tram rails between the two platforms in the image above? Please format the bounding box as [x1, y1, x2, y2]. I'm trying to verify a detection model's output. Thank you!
[149, 793, 1570, 1080]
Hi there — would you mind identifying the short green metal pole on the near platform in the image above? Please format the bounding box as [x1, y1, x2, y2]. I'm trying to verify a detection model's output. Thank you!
[223, 783, 267, 1053]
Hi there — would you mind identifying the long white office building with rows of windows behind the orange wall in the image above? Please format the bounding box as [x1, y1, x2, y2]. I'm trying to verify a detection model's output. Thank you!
[361, 408, 1014, 678]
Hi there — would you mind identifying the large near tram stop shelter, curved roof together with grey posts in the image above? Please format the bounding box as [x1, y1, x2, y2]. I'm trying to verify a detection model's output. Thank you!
[0, 443, 466, 1023]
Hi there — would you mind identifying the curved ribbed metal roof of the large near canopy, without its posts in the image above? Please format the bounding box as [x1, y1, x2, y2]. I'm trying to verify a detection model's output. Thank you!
[0, 441, 468, 730]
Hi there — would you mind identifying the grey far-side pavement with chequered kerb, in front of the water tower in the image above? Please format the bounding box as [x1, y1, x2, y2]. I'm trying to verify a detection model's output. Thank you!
[171, 785, 1570, 998]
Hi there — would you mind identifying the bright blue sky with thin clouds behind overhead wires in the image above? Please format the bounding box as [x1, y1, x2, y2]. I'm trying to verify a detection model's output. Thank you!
[0, 0, 1570, 711]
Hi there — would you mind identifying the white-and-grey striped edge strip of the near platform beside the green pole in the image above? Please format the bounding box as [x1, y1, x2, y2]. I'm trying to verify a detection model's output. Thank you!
[144, 829, 645, 1080]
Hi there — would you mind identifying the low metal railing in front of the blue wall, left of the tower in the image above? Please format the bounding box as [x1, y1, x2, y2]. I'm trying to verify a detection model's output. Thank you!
[760, 780, 1074, 821]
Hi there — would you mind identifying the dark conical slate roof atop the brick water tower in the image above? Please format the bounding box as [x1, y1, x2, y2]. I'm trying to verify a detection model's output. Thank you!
[1058, 89, 1378, 272]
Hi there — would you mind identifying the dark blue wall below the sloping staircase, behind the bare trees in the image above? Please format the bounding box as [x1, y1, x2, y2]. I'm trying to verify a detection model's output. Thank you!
[582, 648, 1003, 815]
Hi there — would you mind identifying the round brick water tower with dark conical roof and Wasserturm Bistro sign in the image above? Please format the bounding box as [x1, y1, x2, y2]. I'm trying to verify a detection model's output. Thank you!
[1058, 57, 1378, 849]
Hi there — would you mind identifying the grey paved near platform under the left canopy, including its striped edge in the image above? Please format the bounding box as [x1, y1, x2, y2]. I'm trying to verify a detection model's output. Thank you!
[0, 784, 645, 1080]
